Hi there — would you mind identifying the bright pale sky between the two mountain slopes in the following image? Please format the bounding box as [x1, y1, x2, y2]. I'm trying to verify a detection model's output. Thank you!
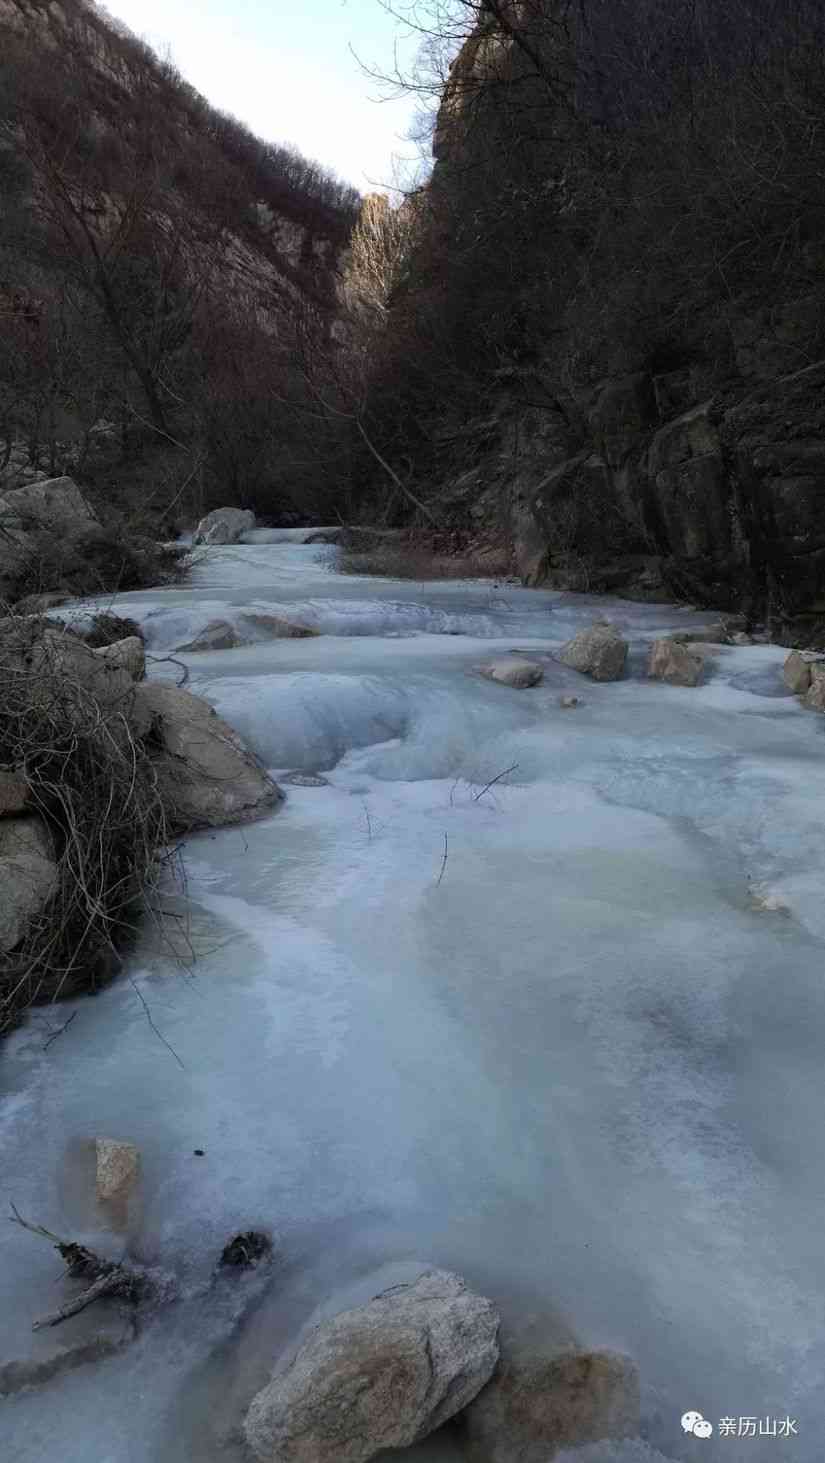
[102, 0, 432, 193]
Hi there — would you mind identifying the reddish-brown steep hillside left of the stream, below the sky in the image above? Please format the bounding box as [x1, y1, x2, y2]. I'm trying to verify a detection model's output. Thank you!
[0, 0, 358, 550]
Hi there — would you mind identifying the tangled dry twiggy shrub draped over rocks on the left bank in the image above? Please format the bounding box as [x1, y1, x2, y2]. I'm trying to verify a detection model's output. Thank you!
[0, 619, 174, 1033]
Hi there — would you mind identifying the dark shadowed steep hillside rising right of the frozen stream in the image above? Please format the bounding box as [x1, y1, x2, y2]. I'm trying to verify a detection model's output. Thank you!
[355, 0, 825, 635]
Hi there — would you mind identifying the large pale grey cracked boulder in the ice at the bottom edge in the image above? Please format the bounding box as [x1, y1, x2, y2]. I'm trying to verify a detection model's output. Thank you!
[244, 1270, 499, 1463]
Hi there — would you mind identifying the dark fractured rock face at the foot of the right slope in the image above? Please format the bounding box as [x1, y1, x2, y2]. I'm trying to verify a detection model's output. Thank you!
[499, 346, 825, 617]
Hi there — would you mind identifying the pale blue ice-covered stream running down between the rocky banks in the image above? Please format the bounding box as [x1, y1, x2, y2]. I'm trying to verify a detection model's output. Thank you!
[0, 538, 825, 1463]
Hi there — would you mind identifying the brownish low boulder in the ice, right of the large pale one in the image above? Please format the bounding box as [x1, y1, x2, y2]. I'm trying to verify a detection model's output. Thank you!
[462, 1350, 639, 1463]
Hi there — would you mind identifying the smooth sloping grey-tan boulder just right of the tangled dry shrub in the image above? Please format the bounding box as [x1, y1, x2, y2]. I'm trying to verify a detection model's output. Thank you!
[135, 682, 284, 832]
